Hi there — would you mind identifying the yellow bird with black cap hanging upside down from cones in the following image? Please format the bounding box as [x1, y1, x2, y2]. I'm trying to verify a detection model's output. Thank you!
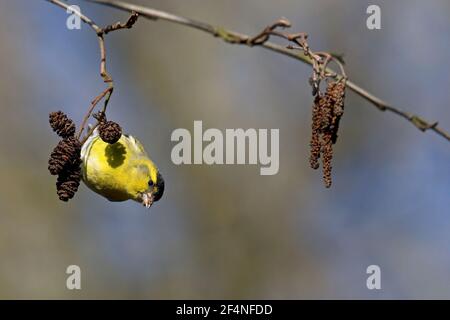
[81, 128, 164, 208]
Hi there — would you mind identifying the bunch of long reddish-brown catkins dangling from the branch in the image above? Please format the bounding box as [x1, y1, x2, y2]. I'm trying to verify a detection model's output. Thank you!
[309, 79, 345, 188]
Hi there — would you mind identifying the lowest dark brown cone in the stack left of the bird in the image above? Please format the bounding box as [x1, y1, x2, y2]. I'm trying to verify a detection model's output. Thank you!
[56, 158, 81, 202]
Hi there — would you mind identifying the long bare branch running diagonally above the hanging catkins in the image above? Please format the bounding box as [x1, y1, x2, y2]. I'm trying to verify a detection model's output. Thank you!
[87, 0, 450, 141]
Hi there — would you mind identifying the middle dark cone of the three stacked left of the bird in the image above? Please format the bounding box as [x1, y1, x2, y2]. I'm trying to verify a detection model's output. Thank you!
[48, 137, 81, 175]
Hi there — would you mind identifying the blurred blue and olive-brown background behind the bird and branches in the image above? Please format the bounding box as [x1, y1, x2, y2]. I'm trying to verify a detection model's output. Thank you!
[0, 0, 450, 299]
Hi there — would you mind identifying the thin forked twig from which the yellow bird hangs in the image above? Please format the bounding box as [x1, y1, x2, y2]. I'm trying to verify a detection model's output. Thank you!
[46, 0, 139, 144]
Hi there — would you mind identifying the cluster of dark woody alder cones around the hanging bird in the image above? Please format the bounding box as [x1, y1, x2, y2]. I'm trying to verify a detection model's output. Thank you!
[48, 111, 122, 202]
